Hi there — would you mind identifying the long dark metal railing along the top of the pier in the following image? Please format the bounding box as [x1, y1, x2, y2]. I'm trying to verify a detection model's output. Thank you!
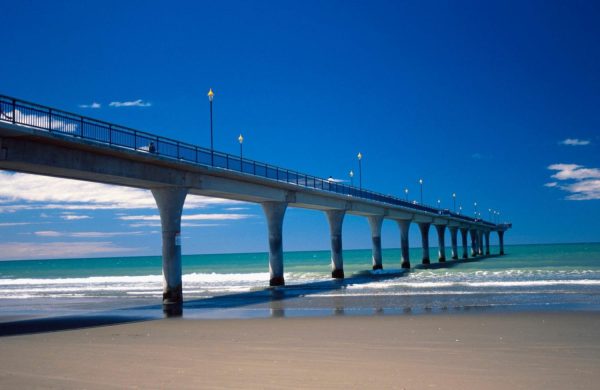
[0, 95, 496, 226]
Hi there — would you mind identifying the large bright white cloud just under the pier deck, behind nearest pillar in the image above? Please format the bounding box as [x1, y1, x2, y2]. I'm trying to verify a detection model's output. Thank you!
[0, 171, 241, 214]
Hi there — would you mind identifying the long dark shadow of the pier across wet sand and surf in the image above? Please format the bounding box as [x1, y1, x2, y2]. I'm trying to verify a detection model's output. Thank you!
[0, 255, 497, 337]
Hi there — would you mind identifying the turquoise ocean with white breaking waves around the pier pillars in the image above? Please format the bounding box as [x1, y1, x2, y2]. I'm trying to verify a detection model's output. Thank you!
[0, 243, 600, 322]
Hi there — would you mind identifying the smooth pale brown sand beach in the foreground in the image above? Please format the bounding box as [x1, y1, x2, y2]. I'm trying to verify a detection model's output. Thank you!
[0, 313, 600, 389]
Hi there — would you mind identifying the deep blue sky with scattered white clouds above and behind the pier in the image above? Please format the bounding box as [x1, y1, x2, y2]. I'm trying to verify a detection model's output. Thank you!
[0, 0, 600, 260]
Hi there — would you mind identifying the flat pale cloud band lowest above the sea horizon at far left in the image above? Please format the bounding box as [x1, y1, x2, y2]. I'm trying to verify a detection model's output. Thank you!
[0, 242, 141, 260]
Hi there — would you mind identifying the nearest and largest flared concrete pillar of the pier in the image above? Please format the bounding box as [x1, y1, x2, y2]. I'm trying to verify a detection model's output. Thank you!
[152, 187, 188, 305]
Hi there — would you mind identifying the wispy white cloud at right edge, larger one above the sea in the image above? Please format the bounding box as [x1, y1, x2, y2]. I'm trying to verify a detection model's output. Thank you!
[545, 164, 600, 200]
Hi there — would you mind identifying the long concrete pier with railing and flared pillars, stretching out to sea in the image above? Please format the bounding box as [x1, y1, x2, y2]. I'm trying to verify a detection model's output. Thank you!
[0, 95, 512, 305]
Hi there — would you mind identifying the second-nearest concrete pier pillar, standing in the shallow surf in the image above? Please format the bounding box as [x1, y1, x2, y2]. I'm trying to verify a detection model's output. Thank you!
[262, 202, 287, 286]
